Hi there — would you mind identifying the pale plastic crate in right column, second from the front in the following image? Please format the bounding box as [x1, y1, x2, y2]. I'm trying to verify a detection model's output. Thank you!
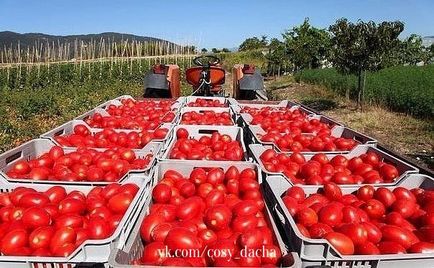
[249, 144, 419, 187]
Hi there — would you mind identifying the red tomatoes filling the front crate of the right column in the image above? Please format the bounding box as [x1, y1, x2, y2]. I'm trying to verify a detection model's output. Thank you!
[282, 183, 434, 255]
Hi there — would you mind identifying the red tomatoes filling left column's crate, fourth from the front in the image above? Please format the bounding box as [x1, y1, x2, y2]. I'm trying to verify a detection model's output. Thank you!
[84, 109, 175, 130]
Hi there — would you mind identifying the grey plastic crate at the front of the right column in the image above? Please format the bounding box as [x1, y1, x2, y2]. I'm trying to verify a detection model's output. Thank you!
[264, 174, 434, 268]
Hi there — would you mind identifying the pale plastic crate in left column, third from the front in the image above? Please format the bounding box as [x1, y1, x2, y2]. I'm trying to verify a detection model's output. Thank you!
[41, 120, 175, 150]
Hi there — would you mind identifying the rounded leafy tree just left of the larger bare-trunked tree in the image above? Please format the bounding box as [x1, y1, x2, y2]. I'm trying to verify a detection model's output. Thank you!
[283, 18, 330, 70]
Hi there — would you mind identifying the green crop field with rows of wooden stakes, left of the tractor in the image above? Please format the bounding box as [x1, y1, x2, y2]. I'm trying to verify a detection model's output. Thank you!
[0, 56, 191, 151]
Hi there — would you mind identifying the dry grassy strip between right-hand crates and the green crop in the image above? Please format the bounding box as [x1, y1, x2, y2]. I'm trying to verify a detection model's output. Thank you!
[267, 76, 434, 169]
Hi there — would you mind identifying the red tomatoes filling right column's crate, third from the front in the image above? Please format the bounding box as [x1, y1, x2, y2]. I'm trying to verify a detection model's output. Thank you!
[260, 132, 359, 152]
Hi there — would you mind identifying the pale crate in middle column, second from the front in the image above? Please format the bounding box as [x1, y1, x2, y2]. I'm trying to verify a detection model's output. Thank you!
[162, 125, 247, 161]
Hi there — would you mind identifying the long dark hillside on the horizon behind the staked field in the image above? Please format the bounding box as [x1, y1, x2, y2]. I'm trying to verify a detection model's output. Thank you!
[0, 31, 173, 48]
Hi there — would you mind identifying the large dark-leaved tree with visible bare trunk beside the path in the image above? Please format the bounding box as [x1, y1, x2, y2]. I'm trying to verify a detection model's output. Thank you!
[329, 19, 404, 108]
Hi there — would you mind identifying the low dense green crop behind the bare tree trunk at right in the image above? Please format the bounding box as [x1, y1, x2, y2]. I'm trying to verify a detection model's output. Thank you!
[295, 65, 434, 118]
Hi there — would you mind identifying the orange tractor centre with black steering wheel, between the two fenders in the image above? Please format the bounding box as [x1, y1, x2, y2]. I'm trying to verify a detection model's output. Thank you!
[185, 55, 225, 96]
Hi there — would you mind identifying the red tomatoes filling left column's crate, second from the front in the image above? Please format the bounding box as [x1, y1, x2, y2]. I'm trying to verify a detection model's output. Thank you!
[6, 146, 152, 182]
